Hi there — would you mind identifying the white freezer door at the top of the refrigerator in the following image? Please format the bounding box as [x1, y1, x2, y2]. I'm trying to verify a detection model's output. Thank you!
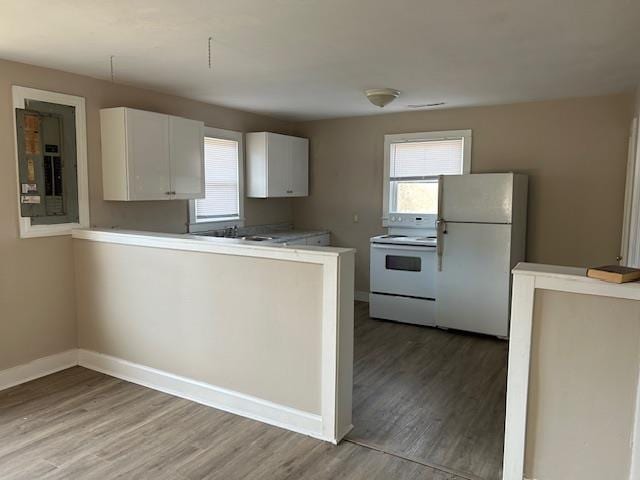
[439, 173, 514, 223]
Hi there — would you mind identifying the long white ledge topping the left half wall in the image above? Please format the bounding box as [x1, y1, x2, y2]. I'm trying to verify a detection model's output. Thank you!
[72, 229, 355, 263]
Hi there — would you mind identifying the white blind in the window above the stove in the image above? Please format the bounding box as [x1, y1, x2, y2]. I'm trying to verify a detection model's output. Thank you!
[390, 138, 464, 181]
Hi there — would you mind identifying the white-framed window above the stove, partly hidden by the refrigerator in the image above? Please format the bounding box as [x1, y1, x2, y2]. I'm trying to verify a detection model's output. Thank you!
[383, 130, 471, 226]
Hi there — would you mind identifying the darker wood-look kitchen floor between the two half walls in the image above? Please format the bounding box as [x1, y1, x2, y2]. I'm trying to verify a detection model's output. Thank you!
[347, 302, 508, 480]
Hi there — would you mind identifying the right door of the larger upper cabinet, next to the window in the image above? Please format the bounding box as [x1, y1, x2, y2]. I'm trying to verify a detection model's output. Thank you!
[169, 116, 204, 199]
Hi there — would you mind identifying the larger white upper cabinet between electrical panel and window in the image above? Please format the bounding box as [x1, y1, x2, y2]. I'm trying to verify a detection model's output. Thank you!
[100, 107, 204, 200]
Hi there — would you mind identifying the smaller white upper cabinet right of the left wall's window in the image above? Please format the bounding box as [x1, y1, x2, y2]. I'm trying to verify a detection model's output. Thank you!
[246, 132, 309, 198]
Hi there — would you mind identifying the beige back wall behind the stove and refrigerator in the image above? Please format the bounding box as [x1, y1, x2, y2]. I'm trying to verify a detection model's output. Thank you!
[294, 94, 633, 290]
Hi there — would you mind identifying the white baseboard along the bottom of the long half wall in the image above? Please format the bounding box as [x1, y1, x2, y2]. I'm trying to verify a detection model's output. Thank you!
[78, 349, 324, 442]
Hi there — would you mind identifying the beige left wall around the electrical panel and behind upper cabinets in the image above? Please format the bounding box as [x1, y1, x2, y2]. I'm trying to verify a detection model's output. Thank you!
[0, 60, 292, 370]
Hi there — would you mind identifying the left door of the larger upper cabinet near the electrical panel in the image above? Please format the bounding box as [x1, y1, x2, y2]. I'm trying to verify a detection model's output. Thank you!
[126, 109, 171, 200]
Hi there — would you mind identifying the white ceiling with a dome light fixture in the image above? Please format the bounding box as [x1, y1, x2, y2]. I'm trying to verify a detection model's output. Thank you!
[0, 0, 640, 120]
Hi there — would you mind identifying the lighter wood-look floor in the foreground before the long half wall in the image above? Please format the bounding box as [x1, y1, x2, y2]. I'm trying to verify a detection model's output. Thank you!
[0, 367, 461, 480]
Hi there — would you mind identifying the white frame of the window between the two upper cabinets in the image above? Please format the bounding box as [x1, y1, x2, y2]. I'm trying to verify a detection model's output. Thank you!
[189, 126, 244, 233]
